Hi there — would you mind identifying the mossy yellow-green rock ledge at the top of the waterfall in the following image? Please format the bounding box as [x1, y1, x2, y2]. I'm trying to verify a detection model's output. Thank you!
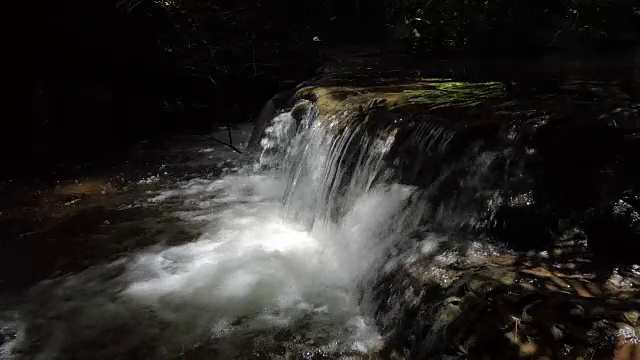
[294, 78, 511, 132]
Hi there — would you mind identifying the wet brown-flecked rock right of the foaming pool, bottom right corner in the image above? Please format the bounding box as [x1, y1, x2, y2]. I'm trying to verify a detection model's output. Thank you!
[376, 245, 640, 359]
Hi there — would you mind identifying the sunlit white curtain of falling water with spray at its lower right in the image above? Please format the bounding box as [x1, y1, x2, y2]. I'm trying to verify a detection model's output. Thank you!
[252, 103, 455, 286]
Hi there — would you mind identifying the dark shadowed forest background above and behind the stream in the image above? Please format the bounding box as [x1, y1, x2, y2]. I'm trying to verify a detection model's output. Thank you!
[10, 0, 640, 178]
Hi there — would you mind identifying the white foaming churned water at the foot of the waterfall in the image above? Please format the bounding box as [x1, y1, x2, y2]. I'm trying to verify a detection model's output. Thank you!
[5, 155, 396, 359]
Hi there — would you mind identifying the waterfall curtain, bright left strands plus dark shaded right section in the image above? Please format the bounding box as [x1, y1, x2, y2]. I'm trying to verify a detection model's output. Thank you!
[259, 100, 508, 240]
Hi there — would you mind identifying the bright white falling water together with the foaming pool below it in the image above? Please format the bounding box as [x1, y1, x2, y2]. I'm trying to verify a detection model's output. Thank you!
[0, 105, 430, 359]
